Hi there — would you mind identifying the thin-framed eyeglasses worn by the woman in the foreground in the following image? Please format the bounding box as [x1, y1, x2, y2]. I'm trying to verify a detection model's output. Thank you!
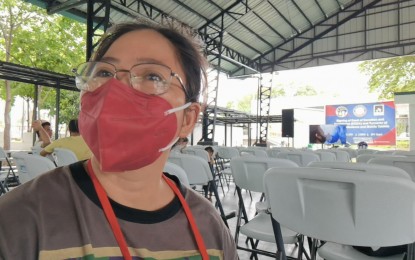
[72, 61, 189, 99]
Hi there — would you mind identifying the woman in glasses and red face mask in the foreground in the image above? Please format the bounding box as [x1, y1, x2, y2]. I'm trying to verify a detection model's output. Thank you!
[0, 23, 238, 260]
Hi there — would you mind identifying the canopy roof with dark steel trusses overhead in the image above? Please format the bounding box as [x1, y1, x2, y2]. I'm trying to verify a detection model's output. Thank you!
[24, 0, 415, 76]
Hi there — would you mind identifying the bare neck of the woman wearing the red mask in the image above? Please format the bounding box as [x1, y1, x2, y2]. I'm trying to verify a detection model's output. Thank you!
[87, 152, 175, 211]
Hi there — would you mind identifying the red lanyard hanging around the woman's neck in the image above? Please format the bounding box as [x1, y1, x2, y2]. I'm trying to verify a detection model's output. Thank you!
[87, 160, 209, 260]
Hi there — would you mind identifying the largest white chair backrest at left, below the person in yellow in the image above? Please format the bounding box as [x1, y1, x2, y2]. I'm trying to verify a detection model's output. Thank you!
[12, 152, 56, 183]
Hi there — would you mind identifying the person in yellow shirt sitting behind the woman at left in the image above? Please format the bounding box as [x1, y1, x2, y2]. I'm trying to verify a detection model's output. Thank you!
[40, 119, 92, 161]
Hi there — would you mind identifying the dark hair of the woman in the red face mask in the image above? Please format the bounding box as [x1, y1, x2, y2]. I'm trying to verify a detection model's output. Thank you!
[91, 21, 207, 102]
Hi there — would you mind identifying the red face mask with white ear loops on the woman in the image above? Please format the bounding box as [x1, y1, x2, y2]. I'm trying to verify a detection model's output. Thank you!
[79, 79, 190, 172]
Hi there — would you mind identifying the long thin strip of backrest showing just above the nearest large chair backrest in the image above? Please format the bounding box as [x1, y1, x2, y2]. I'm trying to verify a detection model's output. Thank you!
[308, 162, 412, 180]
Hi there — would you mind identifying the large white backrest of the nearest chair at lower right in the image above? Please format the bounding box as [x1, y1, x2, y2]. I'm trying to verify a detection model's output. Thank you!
[264, 167, 415, 247]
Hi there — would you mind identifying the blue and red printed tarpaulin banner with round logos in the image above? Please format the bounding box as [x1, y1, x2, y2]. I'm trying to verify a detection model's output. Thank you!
[326, 101, 396, 145]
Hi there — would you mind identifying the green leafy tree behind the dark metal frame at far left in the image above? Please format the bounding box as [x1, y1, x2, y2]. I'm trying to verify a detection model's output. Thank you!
[0, 0, 86, 149]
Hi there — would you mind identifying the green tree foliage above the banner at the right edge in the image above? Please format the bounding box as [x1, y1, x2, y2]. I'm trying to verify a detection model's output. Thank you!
[359, 55, 415, 99]
